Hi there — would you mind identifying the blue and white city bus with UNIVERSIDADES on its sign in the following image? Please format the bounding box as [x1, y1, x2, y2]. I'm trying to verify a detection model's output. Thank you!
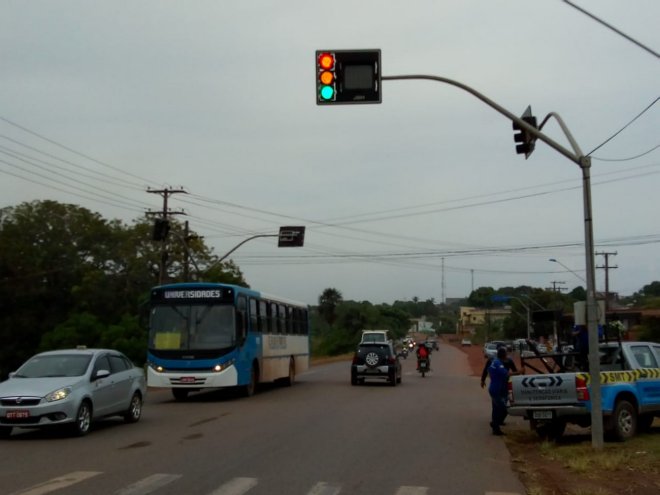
[147, 282, 309, 400]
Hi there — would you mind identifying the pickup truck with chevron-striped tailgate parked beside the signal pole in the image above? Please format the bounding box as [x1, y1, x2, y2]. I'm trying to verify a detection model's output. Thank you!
[509, 342, 660, 440]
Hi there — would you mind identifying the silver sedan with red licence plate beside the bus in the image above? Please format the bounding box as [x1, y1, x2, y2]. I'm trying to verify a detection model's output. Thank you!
[0, 349, 147, 438]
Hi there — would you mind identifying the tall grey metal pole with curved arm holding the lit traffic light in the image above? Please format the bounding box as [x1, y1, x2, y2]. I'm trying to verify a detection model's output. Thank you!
[381, 75, 603, 449]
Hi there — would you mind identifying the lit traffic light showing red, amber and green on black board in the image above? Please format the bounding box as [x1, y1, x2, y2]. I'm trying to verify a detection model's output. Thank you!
[316, 50, 381, 105]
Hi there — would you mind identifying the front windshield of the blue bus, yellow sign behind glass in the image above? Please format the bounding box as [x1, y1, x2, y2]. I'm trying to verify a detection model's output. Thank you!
[149, 304, 236, 350]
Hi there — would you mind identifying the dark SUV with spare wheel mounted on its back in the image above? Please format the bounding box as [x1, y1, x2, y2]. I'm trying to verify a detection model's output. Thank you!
[351, 342, 401, 387]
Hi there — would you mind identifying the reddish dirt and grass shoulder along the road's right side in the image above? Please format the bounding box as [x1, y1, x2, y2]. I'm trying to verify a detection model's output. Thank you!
[445, 340, 660, 495]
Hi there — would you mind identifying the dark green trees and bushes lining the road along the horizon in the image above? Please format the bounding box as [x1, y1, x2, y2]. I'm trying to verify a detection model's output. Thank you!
[0, 201, 660, 380]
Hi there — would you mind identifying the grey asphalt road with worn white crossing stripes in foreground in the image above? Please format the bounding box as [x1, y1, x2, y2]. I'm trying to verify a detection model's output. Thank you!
[0, 345, 525, 495]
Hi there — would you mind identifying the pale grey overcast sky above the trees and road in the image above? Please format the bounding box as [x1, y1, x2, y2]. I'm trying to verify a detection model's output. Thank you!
[0, 0, 660, 304]
